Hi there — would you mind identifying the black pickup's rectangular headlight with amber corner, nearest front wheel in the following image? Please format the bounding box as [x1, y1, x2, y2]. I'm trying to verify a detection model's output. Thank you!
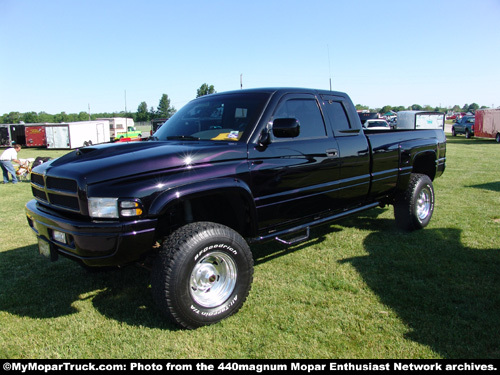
[89, 198, 143, 219]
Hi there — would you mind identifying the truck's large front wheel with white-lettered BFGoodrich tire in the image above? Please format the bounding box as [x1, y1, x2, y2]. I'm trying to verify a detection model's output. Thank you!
[151, 222, 253, 329]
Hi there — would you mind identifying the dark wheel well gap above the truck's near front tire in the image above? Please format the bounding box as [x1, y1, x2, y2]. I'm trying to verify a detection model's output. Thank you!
[159, 189, 256, 241]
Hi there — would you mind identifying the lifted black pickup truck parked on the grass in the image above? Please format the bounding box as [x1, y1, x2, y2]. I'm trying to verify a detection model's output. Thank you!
[26, 88, 446, 328]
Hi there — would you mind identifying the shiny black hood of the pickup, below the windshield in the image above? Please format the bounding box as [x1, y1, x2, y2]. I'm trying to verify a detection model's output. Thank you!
[35, 141, 247, 184]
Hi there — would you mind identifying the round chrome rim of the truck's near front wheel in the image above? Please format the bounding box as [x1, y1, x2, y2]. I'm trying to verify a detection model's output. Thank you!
[190, 252, 238, 308]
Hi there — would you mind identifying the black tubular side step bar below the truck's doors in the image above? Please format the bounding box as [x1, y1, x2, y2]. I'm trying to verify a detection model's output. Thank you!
[249, 202, 380, 245]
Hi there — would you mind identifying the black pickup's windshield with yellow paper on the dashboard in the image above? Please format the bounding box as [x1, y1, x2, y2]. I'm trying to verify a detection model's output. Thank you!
[153, 93, 269, 142]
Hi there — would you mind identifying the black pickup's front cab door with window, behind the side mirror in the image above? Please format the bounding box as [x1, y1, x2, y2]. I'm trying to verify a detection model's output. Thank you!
[249, 94, 339, 229]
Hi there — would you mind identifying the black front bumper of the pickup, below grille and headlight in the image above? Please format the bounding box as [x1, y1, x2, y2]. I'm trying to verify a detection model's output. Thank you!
[26, 199, 157, 267]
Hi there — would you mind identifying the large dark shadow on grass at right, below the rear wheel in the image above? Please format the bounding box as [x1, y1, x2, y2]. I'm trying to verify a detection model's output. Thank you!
[341, 214, 500, 358]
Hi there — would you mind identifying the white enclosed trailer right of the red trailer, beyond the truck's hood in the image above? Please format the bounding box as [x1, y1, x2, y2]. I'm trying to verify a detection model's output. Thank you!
[45, 120, 109, 149]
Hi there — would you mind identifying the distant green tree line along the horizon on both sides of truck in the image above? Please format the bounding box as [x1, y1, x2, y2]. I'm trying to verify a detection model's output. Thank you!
[0, 83, 488, 124]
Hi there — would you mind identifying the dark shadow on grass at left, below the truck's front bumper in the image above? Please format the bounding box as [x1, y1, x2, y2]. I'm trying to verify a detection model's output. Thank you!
[0, 245, 177, 330]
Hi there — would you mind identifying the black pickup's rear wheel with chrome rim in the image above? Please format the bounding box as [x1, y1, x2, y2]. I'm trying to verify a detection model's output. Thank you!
[394, 173, 434, 230]
